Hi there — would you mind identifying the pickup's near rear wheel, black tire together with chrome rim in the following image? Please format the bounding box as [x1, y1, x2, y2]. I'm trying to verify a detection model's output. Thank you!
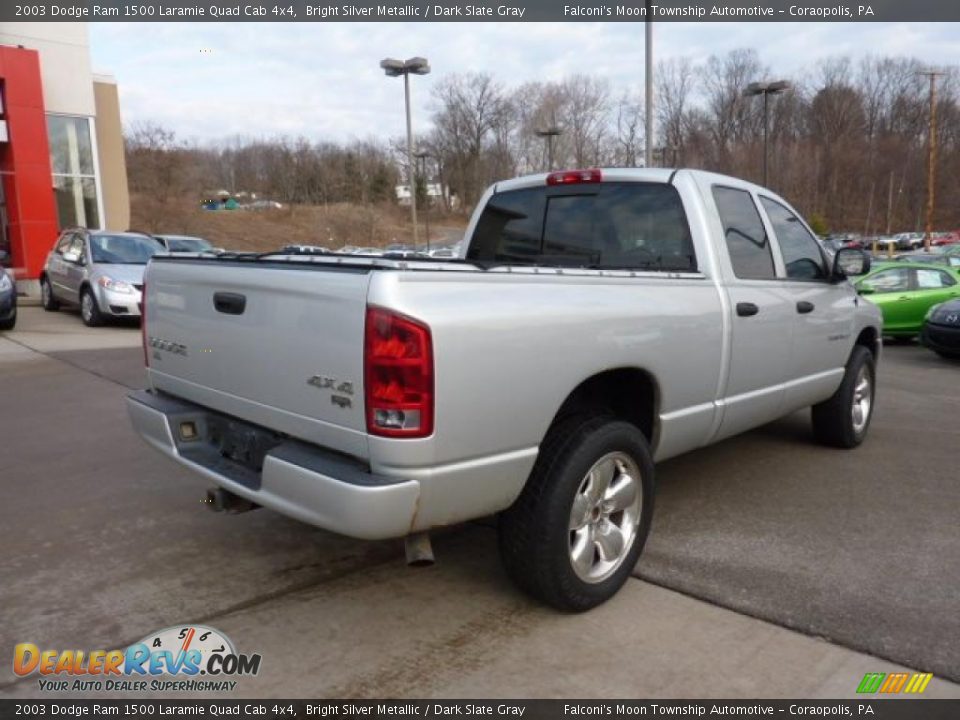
[499, 416, 654, 612]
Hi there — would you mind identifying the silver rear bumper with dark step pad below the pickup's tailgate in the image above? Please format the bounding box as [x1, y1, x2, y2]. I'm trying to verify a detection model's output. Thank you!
[127, 391, 420, 540]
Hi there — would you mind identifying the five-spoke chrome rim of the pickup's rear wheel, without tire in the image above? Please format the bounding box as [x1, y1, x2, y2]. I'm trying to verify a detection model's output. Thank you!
[570, 452, 643, 583]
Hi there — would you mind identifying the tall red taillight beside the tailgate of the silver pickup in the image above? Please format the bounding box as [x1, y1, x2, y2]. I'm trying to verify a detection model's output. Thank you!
[363, 307, 433, 438]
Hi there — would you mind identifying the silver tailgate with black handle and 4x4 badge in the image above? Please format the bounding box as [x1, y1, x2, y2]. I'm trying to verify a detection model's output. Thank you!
[144, 259, 371, 458]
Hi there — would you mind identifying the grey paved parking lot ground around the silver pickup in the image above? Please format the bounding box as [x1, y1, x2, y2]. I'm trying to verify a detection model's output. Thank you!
[0, 307, 960, 698]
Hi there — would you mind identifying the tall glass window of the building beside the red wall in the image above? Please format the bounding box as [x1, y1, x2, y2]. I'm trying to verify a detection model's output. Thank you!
[47, 115, 100, 228]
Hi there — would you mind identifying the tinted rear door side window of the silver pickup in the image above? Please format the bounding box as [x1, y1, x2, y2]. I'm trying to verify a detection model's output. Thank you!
[713, 185, 776, 280]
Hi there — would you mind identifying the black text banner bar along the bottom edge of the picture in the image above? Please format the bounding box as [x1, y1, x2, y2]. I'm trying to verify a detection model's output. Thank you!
[0, 696, 960, 720]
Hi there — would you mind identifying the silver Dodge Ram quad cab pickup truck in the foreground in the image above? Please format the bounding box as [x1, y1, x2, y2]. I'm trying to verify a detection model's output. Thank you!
[128, 169, 881, 610]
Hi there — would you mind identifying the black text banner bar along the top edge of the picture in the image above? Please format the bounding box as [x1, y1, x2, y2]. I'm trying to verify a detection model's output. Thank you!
[0, 0, 960, 22]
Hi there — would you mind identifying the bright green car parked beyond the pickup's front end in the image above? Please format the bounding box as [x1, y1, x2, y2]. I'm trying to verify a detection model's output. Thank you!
[854, 262, 960, 337]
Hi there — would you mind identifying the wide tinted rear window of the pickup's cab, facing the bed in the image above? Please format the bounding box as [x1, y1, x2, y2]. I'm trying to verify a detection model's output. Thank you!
[467, 183, 697, 272]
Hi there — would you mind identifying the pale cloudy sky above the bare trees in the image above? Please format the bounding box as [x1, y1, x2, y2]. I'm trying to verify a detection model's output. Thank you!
[89, 22, 960, 143]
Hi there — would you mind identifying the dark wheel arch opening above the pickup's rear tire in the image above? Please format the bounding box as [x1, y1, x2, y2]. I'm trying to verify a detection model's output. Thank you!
[548, 367, 660, 449]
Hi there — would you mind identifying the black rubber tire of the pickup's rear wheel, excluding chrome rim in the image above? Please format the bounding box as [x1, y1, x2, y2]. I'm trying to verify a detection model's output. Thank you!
[499, 416, 654, 612]
